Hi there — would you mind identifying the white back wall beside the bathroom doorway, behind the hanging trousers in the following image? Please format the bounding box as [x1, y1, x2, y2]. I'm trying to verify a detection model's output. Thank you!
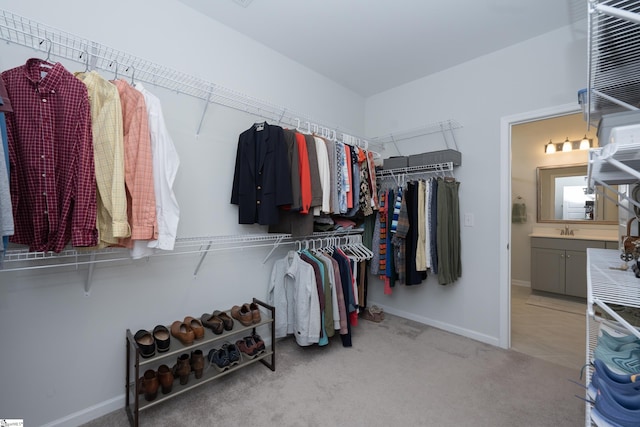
[366, 23, 586, 345]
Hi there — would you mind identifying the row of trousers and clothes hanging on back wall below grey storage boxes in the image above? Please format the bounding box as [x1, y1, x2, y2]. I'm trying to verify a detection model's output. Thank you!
[370, 172, 462, 294]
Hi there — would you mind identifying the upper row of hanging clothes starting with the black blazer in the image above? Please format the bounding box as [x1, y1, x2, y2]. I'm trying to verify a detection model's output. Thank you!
[231, 122, 378, 236]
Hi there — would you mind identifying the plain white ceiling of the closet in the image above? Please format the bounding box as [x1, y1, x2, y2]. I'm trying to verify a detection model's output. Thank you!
[179, 0, 587, 97]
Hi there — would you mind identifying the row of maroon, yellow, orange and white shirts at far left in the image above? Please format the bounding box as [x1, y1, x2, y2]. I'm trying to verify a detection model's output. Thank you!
[0, 58, 180, 258]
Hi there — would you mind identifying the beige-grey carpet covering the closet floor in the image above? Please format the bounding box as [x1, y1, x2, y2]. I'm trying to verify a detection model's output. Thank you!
[82, 314, 584, 427]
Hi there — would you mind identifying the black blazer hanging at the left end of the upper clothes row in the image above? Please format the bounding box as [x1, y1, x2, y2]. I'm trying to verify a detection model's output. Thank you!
[231, 122, 293, 225]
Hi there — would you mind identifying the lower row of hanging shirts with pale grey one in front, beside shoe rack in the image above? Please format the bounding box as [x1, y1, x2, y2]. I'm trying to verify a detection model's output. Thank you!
[268, 236, 373, 347]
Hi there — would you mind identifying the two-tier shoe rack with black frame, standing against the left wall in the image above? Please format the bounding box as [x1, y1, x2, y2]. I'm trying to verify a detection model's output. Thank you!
[125, 298, 276, 427]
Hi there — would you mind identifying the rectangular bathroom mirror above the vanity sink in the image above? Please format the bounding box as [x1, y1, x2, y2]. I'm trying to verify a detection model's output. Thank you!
[536, 163, 618, 224]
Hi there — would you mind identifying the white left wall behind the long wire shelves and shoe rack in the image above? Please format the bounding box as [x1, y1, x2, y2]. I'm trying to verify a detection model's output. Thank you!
[0, 0, 364, 426]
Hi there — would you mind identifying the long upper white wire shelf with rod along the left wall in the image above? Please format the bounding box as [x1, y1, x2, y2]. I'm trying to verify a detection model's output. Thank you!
[0, 9, 366, 145]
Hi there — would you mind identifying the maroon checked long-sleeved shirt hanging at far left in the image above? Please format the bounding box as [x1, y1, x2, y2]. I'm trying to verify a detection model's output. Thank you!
[1, 58, 98, 252]
